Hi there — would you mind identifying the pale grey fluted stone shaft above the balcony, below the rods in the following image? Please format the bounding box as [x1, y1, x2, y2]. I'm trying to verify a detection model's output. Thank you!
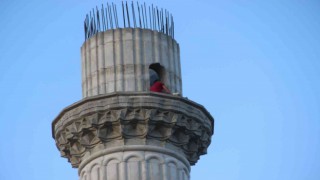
[81, 28, 182, 98]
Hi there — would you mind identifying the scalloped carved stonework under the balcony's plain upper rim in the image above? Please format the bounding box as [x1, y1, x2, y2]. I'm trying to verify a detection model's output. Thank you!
[53, 95, 213, 167]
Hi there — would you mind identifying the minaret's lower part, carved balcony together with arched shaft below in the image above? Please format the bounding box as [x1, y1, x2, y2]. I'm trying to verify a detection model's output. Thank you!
[52, 92, 213, 180]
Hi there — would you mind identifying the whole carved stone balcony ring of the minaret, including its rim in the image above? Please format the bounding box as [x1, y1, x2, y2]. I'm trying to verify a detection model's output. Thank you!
[52, 93, 214, 167]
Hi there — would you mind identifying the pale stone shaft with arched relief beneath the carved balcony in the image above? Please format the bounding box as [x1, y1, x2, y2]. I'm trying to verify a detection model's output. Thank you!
[79, 145, 190, 180]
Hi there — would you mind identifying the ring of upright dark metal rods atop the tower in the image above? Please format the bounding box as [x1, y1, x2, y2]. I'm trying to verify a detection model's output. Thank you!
[84, 1, 174, 40]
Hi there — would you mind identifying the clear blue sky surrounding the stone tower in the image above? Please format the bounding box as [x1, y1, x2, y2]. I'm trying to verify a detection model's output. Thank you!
[0, 0, 320, 180]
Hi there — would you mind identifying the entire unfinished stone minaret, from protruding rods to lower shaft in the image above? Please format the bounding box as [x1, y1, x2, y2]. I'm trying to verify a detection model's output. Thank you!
[52, 3, 214, 180]
